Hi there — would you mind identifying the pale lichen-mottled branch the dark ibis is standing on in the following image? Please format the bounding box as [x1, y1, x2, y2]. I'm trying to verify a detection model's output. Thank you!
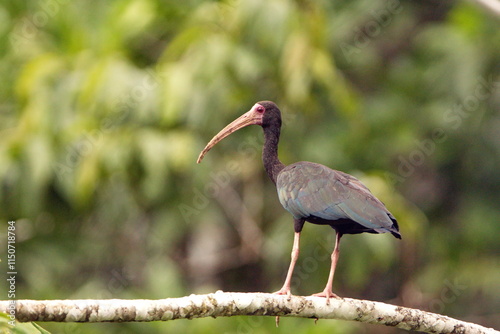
[0, 291, 500, 334]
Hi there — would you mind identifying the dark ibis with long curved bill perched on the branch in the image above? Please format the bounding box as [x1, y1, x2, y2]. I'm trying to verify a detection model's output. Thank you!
[198, 101, 401, 301]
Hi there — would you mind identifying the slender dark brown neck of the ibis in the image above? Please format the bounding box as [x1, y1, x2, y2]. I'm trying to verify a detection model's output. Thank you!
[262, 124, 285, 184]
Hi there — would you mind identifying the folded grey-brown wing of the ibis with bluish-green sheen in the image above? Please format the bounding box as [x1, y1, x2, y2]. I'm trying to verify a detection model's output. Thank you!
[276, 162, 394, 233]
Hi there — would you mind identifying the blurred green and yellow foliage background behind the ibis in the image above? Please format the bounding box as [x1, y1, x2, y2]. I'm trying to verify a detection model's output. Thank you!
[0, 0, 500, 333]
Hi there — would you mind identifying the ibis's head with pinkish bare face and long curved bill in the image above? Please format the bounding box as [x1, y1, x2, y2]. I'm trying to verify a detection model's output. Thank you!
[197, 101, 281, 163]
